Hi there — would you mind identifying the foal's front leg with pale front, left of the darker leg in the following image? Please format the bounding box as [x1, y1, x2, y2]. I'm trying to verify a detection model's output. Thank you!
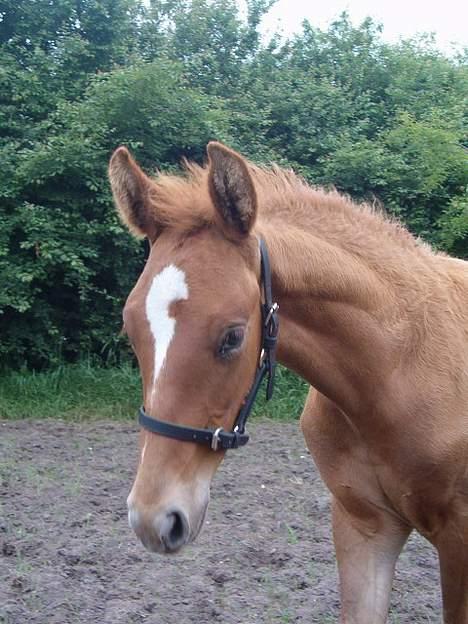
[332, 499, 410, 624]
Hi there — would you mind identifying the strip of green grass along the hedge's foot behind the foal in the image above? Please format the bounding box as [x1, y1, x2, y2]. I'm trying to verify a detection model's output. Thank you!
[0, 362, 307, 421]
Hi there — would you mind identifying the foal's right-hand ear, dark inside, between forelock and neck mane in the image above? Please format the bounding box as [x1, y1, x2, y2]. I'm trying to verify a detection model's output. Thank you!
[207, 141, 257, 238]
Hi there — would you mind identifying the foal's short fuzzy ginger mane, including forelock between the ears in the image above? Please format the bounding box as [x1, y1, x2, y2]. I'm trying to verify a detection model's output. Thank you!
[148, 161, 431, 254]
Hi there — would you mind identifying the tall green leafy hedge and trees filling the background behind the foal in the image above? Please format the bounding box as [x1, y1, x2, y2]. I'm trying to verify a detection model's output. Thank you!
[0, 0, 468, 370]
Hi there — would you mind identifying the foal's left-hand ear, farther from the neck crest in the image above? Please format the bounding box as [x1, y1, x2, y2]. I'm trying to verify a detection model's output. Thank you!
[109, 147, 158, 240]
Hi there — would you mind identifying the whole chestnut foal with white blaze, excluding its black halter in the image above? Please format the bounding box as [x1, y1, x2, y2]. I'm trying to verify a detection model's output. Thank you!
[110, 143, 468, 624]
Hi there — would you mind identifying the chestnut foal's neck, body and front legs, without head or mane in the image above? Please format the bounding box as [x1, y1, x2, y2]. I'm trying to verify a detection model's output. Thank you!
[260, 183, 468, 624]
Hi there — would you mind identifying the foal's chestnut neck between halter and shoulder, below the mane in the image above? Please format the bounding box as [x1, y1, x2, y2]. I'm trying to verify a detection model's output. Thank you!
[259, 217, 422, 413]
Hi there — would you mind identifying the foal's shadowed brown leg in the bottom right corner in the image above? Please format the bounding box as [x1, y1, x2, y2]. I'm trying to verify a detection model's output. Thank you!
[434, 526, 468, 624]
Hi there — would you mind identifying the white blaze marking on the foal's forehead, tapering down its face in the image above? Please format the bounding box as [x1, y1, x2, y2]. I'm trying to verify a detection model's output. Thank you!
[146, 264, 188, 403]
